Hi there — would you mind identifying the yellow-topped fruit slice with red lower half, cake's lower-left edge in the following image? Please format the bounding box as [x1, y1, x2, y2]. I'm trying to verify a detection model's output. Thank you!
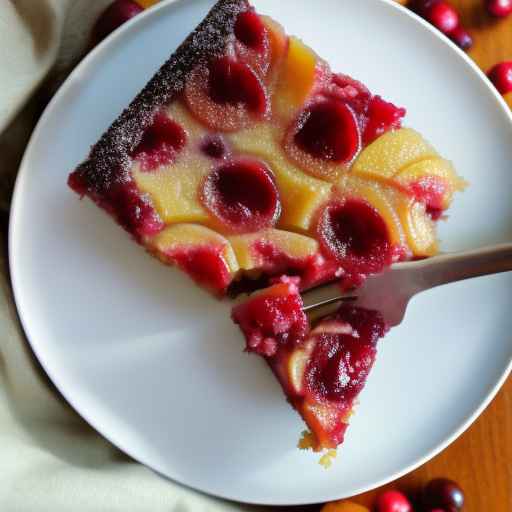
[150, 224, 239, 295]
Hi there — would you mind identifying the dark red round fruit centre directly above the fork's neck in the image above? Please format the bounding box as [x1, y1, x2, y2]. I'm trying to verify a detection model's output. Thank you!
[317, 199, 393, 275]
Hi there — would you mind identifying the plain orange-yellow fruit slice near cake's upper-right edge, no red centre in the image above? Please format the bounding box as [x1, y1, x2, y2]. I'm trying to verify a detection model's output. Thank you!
[273, 37, 318, 121]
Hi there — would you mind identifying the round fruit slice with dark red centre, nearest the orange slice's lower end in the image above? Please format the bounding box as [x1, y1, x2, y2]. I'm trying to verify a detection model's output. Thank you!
[285, 99, 361, 181]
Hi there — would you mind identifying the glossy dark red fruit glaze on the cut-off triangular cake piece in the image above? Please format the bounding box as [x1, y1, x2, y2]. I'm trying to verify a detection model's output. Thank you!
[305, 307, 386, 404]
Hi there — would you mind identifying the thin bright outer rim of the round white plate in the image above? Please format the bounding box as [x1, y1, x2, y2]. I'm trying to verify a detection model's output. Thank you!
[8, 0, 512, 506]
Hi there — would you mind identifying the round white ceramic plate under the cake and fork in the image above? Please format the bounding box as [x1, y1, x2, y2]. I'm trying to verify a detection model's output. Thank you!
[10, 0, 512, 504]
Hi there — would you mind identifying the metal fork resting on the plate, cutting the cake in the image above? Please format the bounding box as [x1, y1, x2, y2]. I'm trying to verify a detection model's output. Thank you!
[303, 243, 512, 326]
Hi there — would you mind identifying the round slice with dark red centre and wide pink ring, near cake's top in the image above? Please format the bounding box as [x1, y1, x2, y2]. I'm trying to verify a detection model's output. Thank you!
[185, 56, 269, 132]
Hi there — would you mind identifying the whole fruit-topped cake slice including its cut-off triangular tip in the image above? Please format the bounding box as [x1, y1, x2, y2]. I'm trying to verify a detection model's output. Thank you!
[69, 0, 464, 456]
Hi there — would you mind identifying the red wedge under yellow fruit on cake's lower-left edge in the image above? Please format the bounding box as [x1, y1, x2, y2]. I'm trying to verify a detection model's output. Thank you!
[166, 246, 231, 295]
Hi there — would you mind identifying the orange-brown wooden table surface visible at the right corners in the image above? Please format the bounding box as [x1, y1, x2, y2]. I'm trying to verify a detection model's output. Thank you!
[348, 0, 512, 512]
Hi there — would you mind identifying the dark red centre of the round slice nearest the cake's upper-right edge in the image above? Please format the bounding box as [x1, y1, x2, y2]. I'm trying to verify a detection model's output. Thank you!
[294, 100, 360, 163]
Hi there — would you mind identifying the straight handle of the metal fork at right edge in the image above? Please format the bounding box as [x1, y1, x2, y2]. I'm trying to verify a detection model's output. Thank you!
[408, 243, 512, 291]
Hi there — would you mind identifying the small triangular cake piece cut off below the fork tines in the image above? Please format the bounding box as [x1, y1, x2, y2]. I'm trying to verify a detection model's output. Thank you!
[232, 277, 388, 456]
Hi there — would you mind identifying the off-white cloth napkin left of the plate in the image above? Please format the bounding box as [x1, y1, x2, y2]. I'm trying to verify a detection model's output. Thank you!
[0, 0, 276, 512]
